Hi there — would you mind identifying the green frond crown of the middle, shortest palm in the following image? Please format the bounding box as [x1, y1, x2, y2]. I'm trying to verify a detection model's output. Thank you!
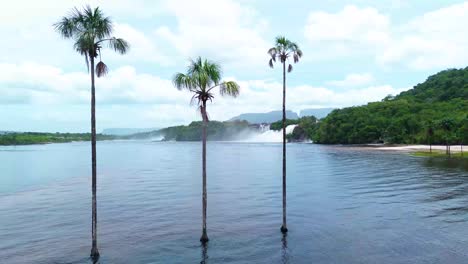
[173, 57, 239, 118]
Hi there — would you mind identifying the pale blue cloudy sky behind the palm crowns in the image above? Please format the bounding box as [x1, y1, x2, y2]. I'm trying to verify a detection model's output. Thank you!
[0, 0, 468, 132]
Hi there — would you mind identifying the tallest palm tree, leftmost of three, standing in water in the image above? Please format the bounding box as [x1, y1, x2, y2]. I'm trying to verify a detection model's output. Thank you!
[54, 6, 129, 259]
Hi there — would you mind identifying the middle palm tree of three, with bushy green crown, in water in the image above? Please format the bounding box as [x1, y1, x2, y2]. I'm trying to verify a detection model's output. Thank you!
[173, 57, 239, 243]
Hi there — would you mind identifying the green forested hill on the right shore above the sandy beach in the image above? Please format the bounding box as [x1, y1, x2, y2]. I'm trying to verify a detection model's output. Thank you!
[313, 67, 468, 144]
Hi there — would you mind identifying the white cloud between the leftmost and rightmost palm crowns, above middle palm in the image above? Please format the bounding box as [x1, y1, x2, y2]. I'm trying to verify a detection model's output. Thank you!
[155, 0, 268, 68]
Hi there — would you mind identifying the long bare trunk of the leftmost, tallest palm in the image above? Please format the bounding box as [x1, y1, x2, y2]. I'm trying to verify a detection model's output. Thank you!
[90, 55, 99, 259]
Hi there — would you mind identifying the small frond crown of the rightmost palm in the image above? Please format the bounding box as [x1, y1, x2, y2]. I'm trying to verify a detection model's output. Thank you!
[268, 36, 302, 72]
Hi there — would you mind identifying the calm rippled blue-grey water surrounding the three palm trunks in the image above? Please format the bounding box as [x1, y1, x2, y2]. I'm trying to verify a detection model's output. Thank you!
[0, 141, 468, 264]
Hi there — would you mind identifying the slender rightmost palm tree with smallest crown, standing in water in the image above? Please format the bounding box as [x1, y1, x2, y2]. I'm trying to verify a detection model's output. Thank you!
[268, 36, 302, 233]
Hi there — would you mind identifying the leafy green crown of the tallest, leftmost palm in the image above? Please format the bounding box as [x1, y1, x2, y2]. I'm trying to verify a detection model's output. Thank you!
[54, 6, 129, 77]
